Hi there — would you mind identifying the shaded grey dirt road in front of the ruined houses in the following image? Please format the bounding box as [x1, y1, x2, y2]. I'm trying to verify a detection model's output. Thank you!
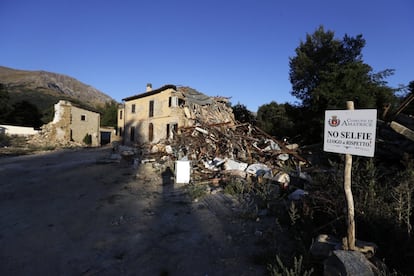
[0, 148, 265, 275]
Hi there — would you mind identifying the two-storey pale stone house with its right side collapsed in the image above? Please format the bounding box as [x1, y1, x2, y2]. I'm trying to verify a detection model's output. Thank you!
[117, 84, 235, 144]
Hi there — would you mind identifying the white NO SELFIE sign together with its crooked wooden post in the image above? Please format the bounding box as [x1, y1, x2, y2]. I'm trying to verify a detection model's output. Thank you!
[323, 101, 377, 250]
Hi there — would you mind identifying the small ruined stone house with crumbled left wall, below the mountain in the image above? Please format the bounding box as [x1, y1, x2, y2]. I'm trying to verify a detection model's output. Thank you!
[48, 100, 101, 146]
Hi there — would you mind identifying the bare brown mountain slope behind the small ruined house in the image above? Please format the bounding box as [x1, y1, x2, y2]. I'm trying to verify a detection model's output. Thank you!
[0, 66, 114, 113]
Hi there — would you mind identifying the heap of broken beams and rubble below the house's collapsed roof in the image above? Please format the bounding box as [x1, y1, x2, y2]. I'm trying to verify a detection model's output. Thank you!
[141, 122, 309, 187]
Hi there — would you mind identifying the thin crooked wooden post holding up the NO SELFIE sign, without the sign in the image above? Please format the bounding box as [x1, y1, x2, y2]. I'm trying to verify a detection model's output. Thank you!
[344, 101, 355, 250]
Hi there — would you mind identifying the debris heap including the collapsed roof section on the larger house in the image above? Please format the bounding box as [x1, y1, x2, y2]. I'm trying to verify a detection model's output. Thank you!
[120, 87, 309, 187]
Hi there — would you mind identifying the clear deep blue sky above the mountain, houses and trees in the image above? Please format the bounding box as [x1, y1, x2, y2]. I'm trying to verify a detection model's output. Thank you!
[0, 0, 414, 112]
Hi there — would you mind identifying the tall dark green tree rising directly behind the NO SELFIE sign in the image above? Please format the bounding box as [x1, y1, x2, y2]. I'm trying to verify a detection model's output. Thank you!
[289, 26, 395, 142]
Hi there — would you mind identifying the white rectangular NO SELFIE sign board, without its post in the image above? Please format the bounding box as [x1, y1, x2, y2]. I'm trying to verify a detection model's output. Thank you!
[323, 109, 377, 157]
